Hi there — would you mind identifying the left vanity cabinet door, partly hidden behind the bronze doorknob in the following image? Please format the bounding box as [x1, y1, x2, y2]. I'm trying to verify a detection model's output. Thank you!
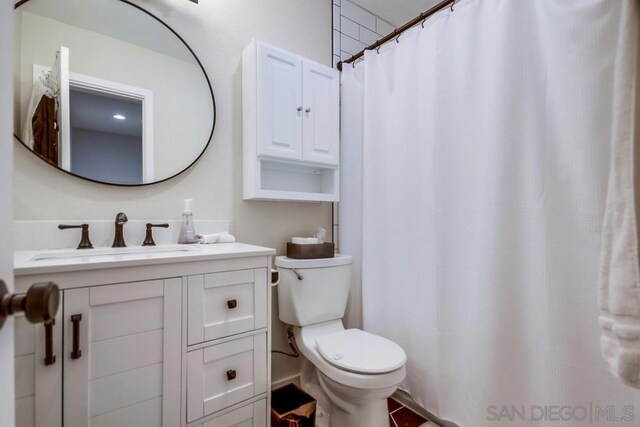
[14, 299, 64, 427]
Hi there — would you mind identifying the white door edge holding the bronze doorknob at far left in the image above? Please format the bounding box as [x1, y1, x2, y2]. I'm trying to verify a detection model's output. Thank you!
[0, 2, 15, 427]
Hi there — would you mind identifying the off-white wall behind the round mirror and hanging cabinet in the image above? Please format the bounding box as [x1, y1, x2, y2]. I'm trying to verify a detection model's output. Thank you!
[14, 0, 332, 381]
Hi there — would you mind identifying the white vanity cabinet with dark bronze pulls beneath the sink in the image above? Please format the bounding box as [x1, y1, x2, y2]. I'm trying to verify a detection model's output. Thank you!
[15, 243, 275, 427]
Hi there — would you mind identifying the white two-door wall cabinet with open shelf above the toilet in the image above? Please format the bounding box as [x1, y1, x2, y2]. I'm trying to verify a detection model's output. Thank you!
[242, 42, 340, 201]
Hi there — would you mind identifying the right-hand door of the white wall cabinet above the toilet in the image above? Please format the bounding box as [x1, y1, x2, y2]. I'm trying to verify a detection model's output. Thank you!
[302, 61, 340, 165]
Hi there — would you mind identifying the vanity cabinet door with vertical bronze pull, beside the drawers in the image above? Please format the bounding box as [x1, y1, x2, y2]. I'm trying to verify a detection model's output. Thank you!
[63, 279, 182, 427]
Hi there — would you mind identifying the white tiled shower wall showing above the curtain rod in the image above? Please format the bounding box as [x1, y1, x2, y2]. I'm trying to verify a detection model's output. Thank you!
[332, 0, 394, 251]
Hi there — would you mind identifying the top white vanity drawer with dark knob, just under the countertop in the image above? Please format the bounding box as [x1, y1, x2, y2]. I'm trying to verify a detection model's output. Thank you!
[187, 268, 268, 345]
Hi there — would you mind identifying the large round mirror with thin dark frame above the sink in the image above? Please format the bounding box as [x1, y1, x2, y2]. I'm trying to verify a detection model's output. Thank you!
[14, 0, 215, 186]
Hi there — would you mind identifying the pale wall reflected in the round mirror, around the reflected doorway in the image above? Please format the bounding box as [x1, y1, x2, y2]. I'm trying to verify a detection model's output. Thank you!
[14, 9, 213, 179]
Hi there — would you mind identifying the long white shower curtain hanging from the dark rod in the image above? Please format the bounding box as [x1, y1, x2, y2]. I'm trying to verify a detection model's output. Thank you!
[340, 0, 640, 427]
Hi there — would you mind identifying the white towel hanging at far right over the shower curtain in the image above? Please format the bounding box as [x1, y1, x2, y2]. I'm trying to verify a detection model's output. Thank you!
[599, 2, 640, 388]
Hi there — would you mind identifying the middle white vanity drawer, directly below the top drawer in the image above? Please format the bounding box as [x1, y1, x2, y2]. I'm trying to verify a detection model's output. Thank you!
[187, 333, 267, 425]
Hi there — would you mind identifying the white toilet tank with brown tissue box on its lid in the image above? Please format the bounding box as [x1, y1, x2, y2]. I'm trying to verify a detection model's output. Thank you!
[276, 255, 353, 326]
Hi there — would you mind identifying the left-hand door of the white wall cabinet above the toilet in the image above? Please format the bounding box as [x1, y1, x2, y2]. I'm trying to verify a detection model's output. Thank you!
[256, 45, 302, 160]
